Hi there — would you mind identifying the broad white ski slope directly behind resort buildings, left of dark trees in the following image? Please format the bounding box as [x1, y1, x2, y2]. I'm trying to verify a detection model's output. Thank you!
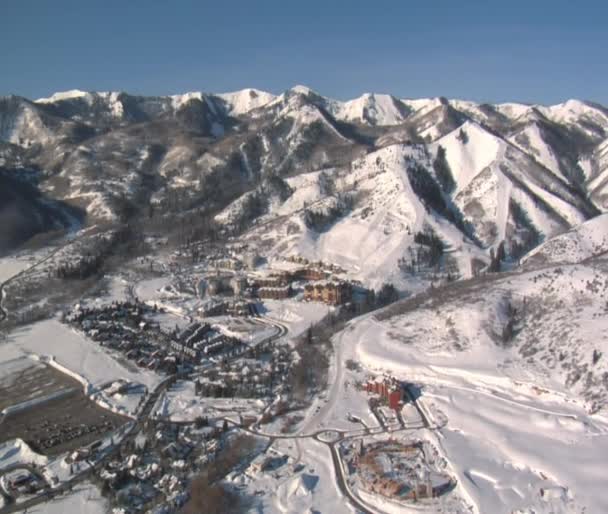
[242, 145, 485, 287]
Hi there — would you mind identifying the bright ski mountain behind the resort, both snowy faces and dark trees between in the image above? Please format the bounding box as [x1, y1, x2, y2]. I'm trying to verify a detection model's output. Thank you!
[223, 117, 593, 288]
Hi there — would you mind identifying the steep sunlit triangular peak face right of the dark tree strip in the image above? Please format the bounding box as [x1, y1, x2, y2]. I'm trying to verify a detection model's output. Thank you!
[429, 122, 588, 244]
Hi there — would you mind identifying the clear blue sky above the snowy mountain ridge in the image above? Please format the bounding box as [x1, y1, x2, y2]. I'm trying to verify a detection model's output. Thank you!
[0, 0, 608, 105]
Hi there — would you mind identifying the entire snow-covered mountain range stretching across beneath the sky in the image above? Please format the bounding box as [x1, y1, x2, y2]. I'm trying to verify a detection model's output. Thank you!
[0, 86, 608, 283]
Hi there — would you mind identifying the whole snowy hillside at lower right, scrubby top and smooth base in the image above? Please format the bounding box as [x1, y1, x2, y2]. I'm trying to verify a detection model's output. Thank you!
[342, 261, 608, 514]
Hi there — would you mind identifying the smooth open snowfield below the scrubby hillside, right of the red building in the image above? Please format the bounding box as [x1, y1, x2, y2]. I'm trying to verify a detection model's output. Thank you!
[330, 281, 608, 514]
